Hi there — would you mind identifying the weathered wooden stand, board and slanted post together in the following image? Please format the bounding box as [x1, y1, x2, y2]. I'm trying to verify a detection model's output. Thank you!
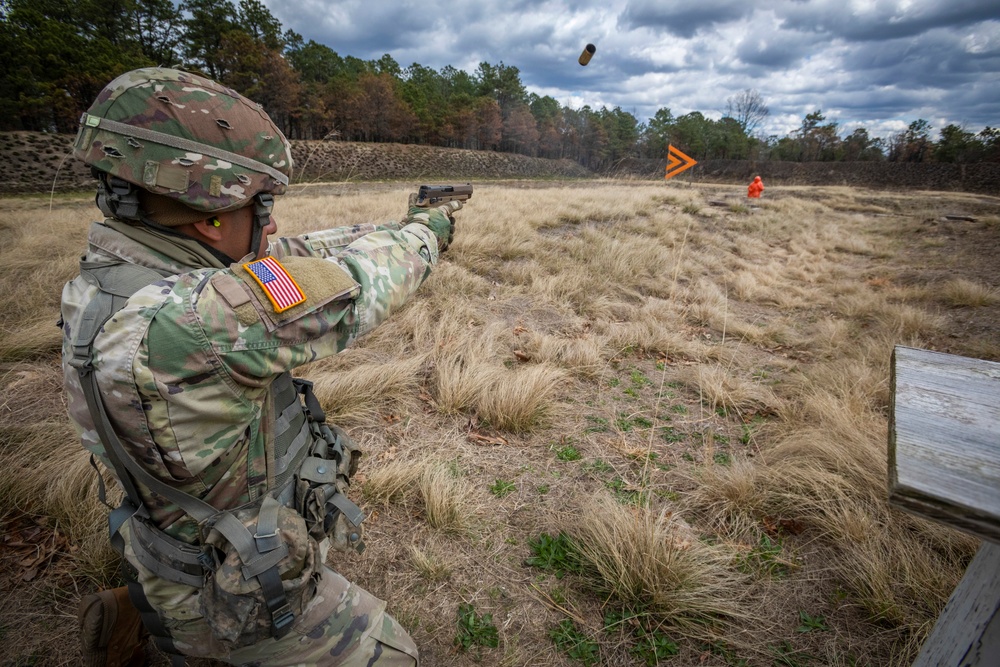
[889, 347, 1000, 667]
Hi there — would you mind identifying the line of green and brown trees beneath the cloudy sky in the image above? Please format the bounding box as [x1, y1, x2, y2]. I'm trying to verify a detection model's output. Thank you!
[0, 0, 1000, 169]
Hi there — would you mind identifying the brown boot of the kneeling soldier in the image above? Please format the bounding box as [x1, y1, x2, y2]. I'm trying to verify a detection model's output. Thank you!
[77, 586, 149, 667]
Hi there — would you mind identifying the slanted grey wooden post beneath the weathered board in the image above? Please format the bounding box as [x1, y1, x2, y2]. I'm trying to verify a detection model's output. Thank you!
[913, 541, 1000, 667]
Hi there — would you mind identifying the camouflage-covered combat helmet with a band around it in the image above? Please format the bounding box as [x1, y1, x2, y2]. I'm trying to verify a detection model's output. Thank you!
[74, 67, 292, 217]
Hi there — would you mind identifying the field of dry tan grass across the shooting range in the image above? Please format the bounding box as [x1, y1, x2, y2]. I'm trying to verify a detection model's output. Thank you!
[0, 181, 1000, 665]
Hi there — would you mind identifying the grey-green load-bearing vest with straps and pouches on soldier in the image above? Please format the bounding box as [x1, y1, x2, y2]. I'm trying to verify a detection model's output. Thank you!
[69, 261, 364, 653]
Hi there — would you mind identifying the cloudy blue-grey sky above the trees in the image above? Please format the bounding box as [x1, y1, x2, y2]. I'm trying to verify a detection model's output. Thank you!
[262, 0, 1000, 139]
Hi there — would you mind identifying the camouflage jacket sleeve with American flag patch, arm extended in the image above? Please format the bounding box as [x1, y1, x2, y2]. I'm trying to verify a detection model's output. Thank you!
[186, 224, 438, 387]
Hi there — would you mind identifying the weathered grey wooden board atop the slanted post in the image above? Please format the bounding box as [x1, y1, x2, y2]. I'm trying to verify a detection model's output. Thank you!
[889, 346, 1000, 541]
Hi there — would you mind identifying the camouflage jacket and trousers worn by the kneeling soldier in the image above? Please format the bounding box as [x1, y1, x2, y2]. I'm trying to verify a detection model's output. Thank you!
[63, 210, 443, 664]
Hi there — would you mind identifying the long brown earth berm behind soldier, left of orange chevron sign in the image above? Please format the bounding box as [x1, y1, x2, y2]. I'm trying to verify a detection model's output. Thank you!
[0, 132, 594, 193]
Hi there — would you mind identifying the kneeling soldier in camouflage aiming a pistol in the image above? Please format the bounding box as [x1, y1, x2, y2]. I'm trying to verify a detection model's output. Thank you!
[61, 68, 461, 665]
